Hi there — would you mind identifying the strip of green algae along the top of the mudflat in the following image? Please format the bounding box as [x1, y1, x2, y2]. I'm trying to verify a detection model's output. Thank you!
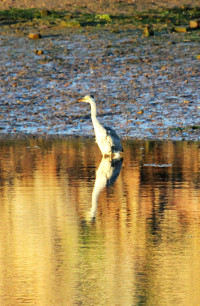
[0, 7, 200, 32]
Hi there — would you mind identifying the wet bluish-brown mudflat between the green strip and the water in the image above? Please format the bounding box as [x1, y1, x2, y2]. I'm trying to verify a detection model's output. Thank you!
[0, 8, 200, 141]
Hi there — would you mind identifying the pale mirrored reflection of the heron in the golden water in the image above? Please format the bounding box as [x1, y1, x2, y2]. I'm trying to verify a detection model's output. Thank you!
[90, 157, 123, 220]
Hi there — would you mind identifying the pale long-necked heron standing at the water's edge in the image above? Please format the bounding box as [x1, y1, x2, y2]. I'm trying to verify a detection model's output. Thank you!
[78, 95, 123, 158]
